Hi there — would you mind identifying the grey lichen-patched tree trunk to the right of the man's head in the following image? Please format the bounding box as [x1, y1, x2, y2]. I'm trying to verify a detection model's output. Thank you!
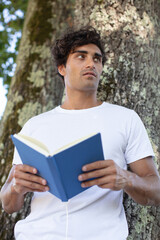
[75, 0, 160, 240]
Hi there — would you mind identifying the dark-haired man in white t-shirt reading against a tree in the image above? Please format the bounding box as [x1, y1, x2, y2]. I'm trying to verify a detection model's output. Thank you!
[1, 27, 160, 240]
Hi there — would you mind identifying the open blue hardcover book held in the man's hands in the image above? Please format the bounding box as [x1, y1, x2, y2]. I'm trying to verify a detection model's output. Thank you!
[11, 133, 104, 202]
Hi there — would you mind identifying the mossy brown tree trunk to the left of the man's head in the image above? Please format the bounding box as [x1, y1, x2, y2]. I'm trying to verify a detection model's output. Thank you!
[0, 0, 74, 240]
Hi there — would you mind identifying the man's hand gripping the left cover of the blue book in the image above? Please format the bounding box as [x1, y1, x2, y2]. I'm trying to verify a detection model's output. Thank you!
[11, 164, 49, 195]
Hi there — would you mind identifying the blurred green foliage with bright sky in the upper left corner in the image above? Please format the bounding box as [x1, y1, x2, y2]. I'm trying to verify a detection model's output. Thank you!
[0, 0, 28, 89]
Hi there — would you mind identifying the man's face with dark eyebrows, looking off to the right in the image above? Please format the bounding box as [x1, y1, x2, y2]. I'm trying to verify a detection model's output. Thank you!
[58, 44, 103, 91]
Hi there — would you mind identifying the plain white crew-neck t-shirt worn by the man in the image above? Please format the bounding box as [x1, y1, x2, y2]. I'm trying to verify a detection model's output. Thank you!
[13, 102, 154, 240]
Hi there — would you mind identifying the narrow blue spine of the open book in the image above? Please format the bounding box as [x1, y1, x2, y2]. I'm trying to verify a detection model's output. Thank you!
[49, 156, 68, 202]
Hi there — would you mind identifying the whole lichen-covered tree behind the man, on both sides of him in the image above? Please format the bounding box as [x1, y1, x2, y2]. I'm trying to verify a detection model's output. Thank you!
[0, 0, 160, 240]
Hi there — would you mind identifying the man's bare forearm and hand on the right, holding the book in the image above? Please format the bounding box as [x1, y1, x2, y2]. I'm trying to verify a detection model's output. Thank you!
[78, 157, 160, 205]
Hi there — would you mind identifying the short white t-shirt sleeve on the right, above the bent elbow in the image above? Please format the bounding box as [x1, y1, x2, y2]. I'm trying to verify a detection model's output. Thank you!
[125, 111, 154, 164]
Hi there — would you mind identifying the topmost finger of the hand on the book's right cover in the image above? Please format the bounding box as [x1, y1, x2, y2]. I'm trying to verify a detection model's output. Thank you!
[82, 160, 114, 172]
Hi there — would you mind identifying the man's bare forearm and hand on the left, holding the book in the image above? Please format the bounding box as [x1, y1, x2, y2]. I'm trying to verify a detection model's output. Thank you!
[0, 164, 49, 213]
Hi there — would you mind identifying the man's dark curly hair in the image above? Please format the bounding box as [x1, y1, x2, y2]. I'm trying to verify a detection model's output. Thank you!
[52, 26, 106, 71]
